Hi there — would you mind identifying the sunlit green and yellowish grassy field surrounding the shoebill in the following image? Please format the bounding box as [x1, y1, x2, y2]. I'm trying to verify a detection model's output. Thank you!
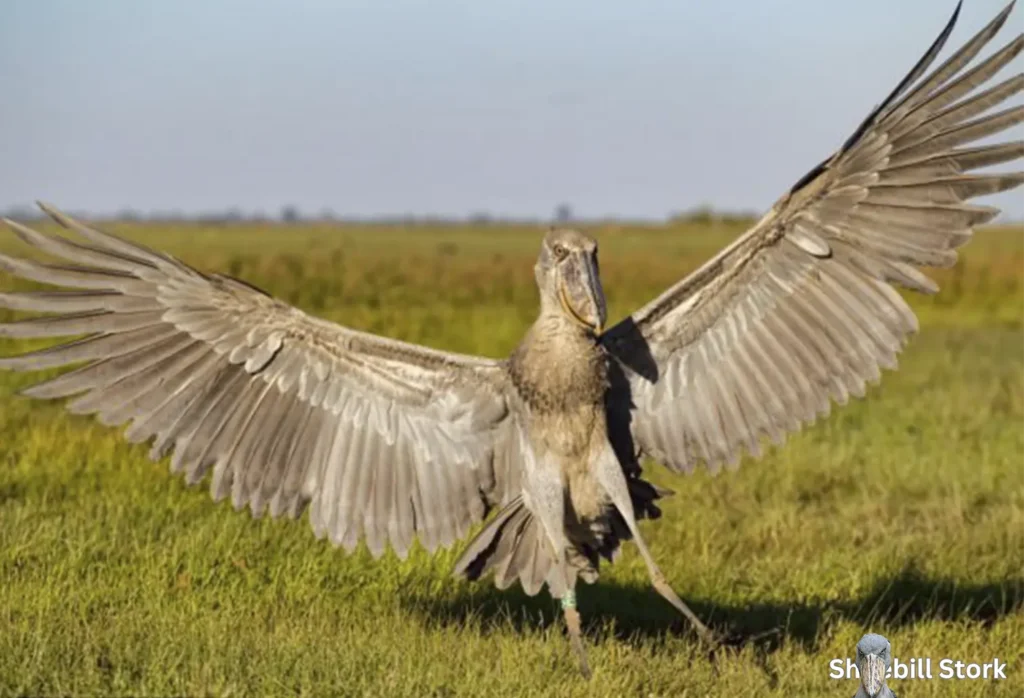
[0, 220, 1024, 698]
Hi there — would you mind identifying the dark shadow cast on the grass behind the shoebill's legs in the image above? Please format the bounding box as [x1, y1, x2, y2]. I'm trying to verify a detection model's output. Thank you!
[403, 567, 1024, 652]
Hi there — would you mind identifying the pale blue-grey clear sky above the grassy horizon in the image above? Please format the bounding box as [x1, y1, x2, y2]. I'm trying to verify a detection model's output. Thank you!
[0, 0, 1024, 218]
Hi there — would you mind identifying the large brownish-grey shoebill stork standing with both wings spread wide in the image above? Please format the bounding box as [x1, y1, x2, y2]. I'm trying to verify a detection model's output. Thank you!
[0, 0, 1024, 673]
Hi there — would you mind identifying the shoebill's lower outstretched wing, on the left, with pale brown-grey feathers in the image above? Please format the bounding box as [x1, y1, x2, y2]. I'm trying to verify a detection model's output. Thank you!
[0, 202, 517, 556]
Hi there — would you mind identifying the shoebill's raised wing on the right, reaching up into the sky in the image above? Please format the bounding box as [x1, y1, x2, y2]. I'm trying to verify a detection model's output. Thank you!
[603, 5, 1024, 471]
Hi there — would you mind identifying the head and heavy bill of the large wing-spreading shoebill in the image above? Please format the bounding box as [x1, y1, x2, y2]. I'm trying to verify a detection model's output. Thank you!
[534, 228, 607, 335]
